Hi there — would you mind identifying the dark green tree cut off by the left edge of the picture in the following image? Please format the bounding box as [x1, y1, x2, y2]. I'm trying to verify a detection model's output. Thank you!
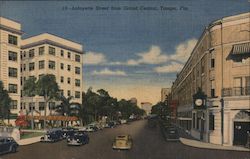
[0, 81, 11, 122]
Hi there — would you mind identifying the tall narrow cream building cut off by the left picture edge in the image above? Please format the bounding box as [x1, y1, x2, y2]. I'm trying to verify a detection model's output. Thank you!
[0, 17, 22, 123]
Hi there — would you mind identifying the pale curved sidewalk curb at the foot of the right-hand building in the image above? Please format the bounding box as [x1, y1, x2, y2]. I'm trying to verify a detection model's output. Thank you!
[180, 138, 250, 152]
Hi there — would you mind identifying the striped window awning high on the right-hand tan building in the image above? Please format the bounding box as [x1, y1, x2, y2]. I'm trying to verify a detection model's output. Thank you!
[231, 42, 250, 55]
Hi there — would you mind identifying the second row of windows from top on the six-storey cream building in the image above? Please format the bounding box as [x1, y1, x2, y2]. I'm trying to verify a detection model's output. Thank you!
[21, 60, 81, 74]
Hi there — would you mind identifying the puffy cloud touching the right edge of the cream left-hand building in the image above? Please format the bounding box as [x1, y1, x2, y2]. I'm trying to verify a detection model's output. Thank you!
[83, 51, 107, 65]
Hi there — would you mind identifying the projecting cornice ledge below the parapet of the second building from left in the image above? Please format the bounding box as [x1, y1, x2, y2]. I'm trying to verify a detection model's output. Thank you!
[21, 39, 84, 54]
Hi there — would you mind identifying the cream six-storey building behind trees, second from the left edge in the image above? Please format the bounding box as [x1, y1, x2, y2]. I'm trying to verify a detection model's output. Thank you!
[20, 33, 83, 115]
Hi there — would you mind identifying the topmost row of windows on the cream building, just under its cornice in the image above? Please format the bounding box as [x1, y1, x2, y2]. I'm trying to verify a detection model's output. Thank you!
[21, 46, 81, 62]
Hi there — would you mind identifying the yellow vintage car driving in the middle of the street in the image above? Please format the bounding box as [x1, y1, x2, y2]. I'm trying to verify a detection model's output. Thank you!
[112, 135, 133, 150]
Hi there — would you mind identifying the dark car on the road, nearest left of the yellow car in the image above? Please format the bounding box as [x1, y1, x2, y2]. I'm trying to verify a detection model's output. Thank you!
[67, 131, 89, 146]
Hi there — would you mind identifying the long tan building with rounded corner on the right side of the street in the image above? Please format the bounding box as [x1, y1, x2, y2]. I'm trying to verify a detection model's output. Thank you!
[171, 13, 250, 145]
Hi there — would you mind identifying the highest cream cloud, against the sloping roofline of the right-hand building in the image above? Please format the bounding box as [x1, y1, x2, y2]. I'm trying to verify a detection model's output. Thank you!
[170, 39, 197, 63]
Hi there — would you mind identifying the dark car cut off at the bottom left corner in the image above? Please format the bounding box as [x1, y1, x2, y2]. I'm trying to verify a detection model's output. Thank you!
[0, 137, 19, 154]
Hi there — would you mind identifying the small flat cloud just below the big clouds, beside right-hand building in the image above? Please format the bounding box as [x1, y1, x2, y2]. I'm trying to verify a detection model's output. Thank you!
[154, 62, 183, 73]
